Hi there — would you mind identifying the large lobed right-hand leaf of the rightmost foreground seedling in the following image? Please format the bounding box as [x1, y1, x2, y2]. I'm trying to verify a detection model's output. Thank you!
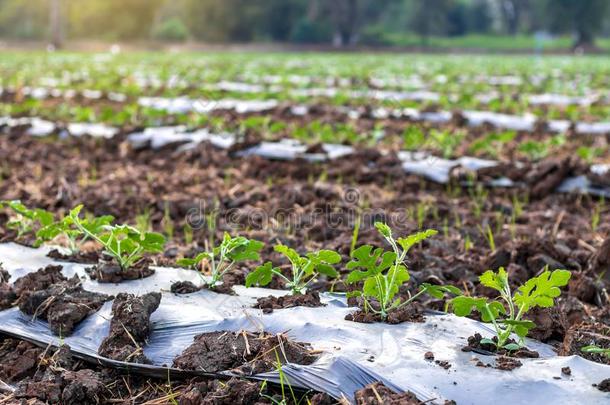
[514, 270, 572, 313]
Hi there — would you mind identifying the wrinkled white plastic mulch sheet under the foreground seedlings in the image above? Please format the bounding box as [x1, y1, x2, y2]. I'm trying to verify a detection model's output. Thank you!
[0, 244, 610, 404]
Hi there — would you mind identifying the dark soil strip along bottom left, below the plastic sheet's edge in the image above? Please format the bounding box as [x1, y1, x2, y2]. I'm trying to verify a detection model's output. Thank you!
[0, 335, 336, 405]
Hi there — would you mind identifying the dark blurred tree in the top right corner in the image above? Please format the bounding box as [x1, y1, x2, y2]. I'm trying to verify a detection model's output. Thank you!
[547, 0, 608, 49]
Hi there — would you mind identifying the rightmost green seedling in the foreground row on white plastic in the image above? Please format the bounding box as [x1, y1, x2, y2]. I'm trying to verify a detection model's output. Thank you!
[451, 267, 571, 350]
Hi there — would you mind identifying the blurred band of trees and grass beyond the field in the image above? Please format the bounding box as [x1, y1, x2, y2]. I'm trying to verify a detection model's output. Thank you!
[0, 0, 610, 52]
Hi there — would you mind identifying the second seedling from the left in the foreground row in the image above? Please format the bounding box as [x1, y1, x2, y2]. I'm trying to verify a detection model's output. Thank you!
[68, 205, 165, 270]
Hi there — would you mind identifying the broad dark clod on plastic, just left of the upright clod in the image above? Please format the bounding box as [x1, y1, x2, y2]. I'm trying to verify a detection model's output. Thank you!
[19, 276, 112, 336]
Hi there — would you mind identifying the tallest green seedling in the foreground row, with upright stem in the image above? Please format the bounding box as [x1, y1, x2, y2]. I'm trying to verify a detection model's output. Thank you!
[346, 222, 460, 319]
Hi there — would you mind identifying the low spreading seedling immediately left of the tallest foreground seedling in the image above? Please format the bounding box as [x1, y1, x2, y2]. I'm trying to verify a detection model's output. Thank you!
[246, 244, 341, 294]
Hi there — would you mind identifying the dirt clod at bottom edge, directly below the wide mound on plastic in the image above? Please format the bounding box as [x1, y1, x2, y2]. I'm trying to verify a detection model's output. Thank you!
[180, 378, 261, 405]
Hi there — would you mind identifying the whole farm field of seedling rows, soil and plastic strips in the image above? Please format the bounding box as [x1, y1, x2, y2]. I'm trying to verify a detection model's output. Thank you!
[0, 52, 610, 404]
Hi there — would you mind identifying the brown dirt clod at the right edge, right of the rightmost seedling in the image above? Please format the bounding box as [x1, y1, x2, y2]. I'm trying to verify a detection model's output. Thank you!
[559, 323, 610, 364]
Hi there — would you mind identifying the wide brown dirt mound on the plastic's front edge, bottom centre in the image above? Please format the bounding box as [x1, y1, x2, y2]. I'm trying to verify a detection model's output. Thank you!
[169, 331, 317, 375]
